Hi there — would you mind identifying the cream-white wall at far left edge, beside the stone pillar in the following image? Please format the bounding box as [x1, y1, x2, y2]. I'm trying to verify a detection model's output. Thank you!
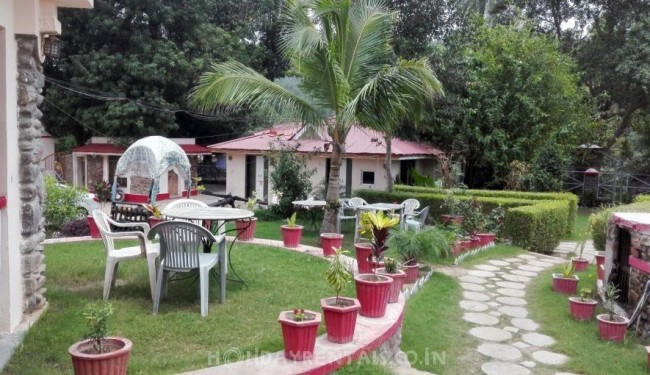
[0, 0, 23, 333]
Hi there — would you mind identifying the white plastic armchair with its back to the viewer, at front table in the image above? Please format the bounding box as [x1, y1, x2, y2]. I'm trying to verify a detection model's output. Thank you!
[148, 221, 226, 316]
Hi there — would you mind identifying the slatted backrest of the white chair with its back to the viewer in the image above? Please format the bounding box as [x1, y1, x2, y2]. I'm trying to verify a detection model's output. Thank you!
[148, 221, 216, 271]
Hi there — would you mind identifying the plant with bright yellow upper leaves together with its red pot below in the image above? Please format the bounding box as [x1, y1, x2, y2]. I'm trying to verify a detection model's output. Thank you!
[354, 211, 399, 318]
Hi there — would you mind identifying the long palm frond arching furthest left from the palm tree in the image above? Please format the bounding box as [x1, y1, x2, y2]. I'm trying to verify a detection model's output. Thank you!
[189, 61, 322, 124]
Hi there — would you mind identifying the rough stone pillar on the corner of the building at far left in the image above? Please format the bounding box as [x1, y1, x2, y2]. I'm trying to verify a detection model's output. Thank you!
[16, 34, 45, 313]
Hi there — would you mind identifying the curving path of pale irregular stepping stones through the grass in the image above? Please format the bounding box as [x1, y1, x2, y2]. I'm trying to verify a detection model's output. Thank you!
[459, 254, 569, 375]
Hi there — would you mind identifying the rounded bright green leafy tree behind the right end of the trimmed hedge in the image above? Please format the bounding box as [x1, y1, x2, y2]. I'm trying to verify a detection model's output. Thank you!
[412, 20, 593, 187]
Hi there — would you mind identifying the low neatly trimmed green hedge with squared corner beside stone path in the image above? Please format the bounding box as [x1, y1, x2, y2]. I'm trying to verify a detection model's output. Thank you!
[355, 185, 578, 253]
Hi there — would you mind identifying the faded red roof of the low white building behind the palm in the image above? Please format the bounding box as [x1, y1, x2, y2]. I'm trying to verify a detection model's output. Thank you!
[208, 123, 442, 158]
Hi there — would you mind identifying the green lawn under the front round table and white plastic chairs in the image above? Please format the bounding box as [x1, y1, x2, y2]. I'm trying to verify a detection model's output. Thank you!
[5, 241, 354, 375]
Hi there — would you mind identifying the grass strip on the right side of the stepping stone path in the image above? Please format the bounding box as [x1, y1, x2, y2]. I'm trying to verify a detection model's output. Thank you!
[526, 266, 648, 375]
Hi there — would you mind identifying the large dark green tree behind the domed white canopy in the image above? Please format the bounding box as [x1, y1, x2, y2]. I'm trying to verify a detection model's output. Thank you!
[45, 0, 262, 144]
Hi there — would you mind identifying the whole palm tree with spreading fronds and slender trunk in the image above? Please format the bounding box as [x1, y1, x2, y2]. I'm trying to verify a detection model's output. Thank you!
[190, 0, 440, 232]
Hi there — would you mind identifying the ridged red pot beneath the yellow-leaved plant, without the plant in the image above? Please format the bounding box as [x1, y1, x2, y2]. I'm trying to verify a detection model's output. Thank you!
[354, 274, 393, 318]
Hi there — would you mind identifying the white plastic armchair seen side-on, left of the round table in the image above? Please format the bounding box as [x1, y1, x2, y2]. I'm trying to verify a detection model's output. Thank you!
[93, 209, 160, 300]
